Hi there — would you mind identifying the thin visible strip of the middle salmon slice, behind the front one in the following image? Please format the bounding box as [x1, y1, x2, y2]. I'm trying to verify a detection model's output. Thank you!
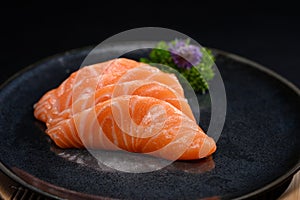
[47, 80, 195, 127]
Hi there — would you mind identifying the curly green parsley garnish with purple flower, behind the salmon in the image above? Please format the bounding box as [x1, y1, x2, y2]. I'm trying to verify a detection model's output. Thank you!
[140, 40, 215, 93]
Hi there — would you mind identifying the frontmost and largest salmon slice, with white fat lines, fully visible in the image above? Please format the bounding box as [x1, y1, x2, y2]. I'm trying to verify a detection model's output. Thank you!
[47, 95, 216, 160]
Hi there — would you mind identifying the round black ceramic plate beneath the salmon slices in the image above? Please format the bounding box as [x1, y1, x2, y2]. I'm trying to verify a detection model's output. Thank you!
[0, 44, 300, 199]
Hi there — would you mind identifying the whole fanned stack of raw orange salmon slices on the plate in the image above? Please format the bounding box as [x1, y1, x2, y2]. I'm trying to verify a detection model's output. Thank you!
[34, 58, 216, 160]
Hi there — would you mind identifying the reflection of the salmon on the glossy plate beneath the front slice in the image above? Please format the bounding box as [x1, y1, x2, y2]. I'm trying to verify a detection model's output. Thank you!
[51, 144, 215, 174]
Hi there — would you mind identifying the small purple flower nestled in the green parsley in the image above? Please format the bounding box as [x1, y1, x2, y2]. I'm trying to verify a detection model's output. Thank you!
[169, 40, 202, 69]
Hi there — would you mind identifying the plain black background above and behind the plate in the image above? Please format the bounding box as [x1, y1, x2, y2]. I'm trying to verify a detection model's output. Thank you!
[0, 5, 300, 87]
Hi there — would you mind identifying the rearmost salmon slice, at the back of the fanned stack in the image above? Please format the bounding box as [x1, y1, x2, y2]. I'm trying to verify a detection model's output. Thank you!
[34, 58, 184, 123]
